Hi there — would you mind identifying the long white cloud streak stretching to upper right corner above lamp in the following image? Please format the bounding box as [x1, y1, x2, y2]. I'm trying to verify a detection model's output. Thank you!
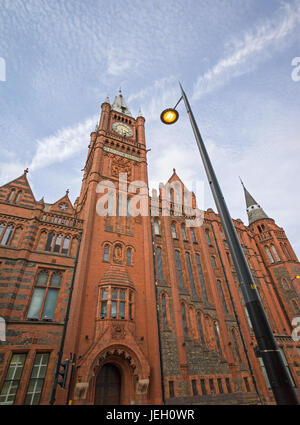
[193, 3, 300, 99]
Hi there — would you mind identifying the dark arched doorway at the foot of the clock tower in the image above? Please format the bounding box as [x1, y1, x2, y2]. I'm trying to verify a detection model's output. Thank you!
[94, 363, 121, 405]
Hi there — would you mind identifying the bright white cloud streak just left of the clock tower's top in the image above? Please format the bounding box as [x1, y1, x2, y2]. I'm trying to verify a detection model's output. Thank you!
[29, 116, 98, 171]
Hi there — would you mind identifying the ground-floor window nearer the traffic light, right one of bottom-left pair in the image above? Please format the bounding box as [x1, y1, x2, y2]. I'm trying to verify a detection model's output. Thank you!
[24, 353, 49, 405]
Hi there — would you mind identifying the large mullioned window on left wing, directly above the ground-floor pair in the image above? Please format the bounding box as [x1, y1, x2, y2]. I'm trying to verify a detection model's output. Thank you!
[27, 270, 61, 320]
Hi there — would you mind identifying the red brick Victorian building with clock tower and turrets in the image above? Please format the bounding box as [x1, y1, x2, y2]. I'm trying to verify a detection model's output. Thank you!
[0, 93, 300, 404]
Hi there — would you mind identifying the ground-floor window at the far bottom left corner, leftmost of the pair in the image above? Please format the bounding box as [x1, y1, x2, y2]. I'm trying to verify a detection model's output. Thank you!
[0, 354, 26, 405]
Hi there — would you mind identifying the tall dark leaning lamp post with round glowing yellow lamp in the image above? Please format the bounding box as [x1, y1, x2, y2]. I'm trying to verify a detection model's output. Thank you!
[161, 84, 299, 405]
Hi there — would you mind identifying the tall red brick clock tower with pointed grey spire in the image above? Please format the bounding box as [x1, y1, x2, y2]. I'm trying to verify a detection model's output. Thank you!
[57, 90, 162, 404]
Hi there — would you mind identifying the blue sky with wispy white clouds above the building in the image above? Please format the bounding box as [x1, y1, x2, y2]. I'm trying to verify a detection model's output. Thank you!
[0, 0, 300, 257]
